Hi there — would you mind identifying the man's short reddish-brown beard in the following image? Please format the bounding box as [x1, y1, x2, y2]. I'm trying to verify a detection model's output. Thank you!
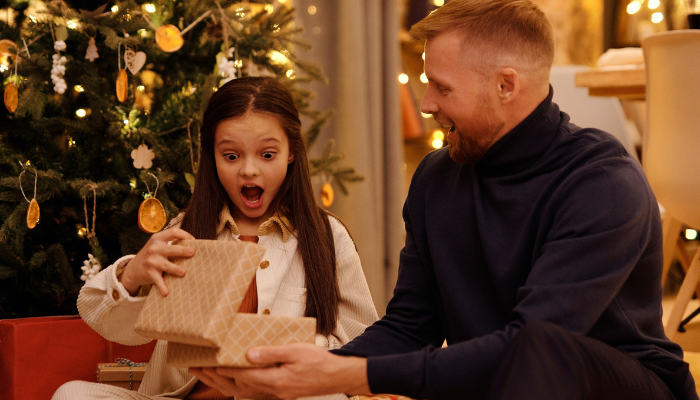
[448, 96, 505, 164]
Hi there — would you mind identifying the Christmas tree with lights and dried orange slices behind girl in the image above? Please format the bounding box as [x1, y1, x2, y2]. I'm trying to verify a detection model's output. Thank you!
[0, 0, 362, 319]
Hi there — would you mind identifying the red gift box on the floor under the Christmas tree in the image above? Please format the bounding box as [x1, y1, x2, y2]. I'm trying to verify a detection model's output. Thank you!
[0, 315, 156, 400]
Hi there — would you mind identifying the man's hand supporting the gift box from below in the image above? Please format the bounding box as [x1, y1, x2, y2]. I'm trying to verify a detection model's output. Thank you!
[190, 343, 370, 399]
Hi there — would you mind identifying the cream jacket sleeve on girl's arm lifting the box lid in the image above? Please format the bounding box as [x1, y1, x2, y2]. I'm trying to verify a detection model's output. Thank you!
[78, 255, 152, 346]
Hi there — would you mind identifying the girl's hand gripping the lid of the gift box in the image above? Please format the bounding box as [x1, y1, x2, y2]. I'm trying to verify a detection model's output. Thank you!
[120, 228, 194, 296]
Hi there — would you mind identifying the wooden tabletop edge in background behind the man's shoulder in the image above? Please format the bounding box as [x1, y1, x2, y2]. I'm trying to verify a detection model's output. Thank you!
[576, 67, 647, 100]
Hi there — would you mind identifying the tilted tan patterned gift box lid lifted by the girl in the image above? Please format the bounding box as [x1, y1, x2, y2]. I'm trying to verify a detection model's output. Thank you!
[134, 240, 265, 347]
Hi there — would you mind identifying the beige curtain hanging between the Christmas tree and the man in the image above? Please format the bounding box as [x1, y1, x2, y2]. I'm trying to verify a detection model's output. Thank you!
[293, 0, 405, 316]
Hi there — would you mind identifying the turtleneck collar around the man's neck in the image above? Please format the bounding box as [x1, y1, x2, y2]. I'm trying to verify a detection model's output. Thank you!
[475, 85, 561, 177]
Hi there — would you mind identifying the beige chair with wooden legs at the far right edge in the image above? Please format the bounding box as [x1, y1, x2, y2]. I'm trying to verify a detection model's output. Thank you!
[642, 30, 700, 340]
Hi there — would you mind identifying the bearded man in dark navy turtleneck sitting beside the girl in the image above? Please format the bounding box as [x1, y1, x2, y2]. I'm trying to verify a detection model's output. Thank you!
[193, 0, 697, 400]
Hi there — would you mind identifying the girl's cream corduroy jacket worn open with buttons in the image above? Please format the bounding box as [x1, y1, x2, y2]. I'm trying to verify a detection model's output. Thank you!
[78, 208, 377, 399]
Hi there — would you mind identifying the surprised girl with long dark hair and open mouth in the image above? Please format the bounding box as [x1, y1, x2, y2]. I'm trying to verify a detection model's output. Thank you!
[53, 77, 377, 400]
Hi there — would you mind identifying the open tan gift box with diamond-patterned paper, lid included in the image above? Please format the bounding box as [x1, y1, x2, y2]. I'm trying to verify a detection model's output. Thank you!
[135, 240, 316, 367]
